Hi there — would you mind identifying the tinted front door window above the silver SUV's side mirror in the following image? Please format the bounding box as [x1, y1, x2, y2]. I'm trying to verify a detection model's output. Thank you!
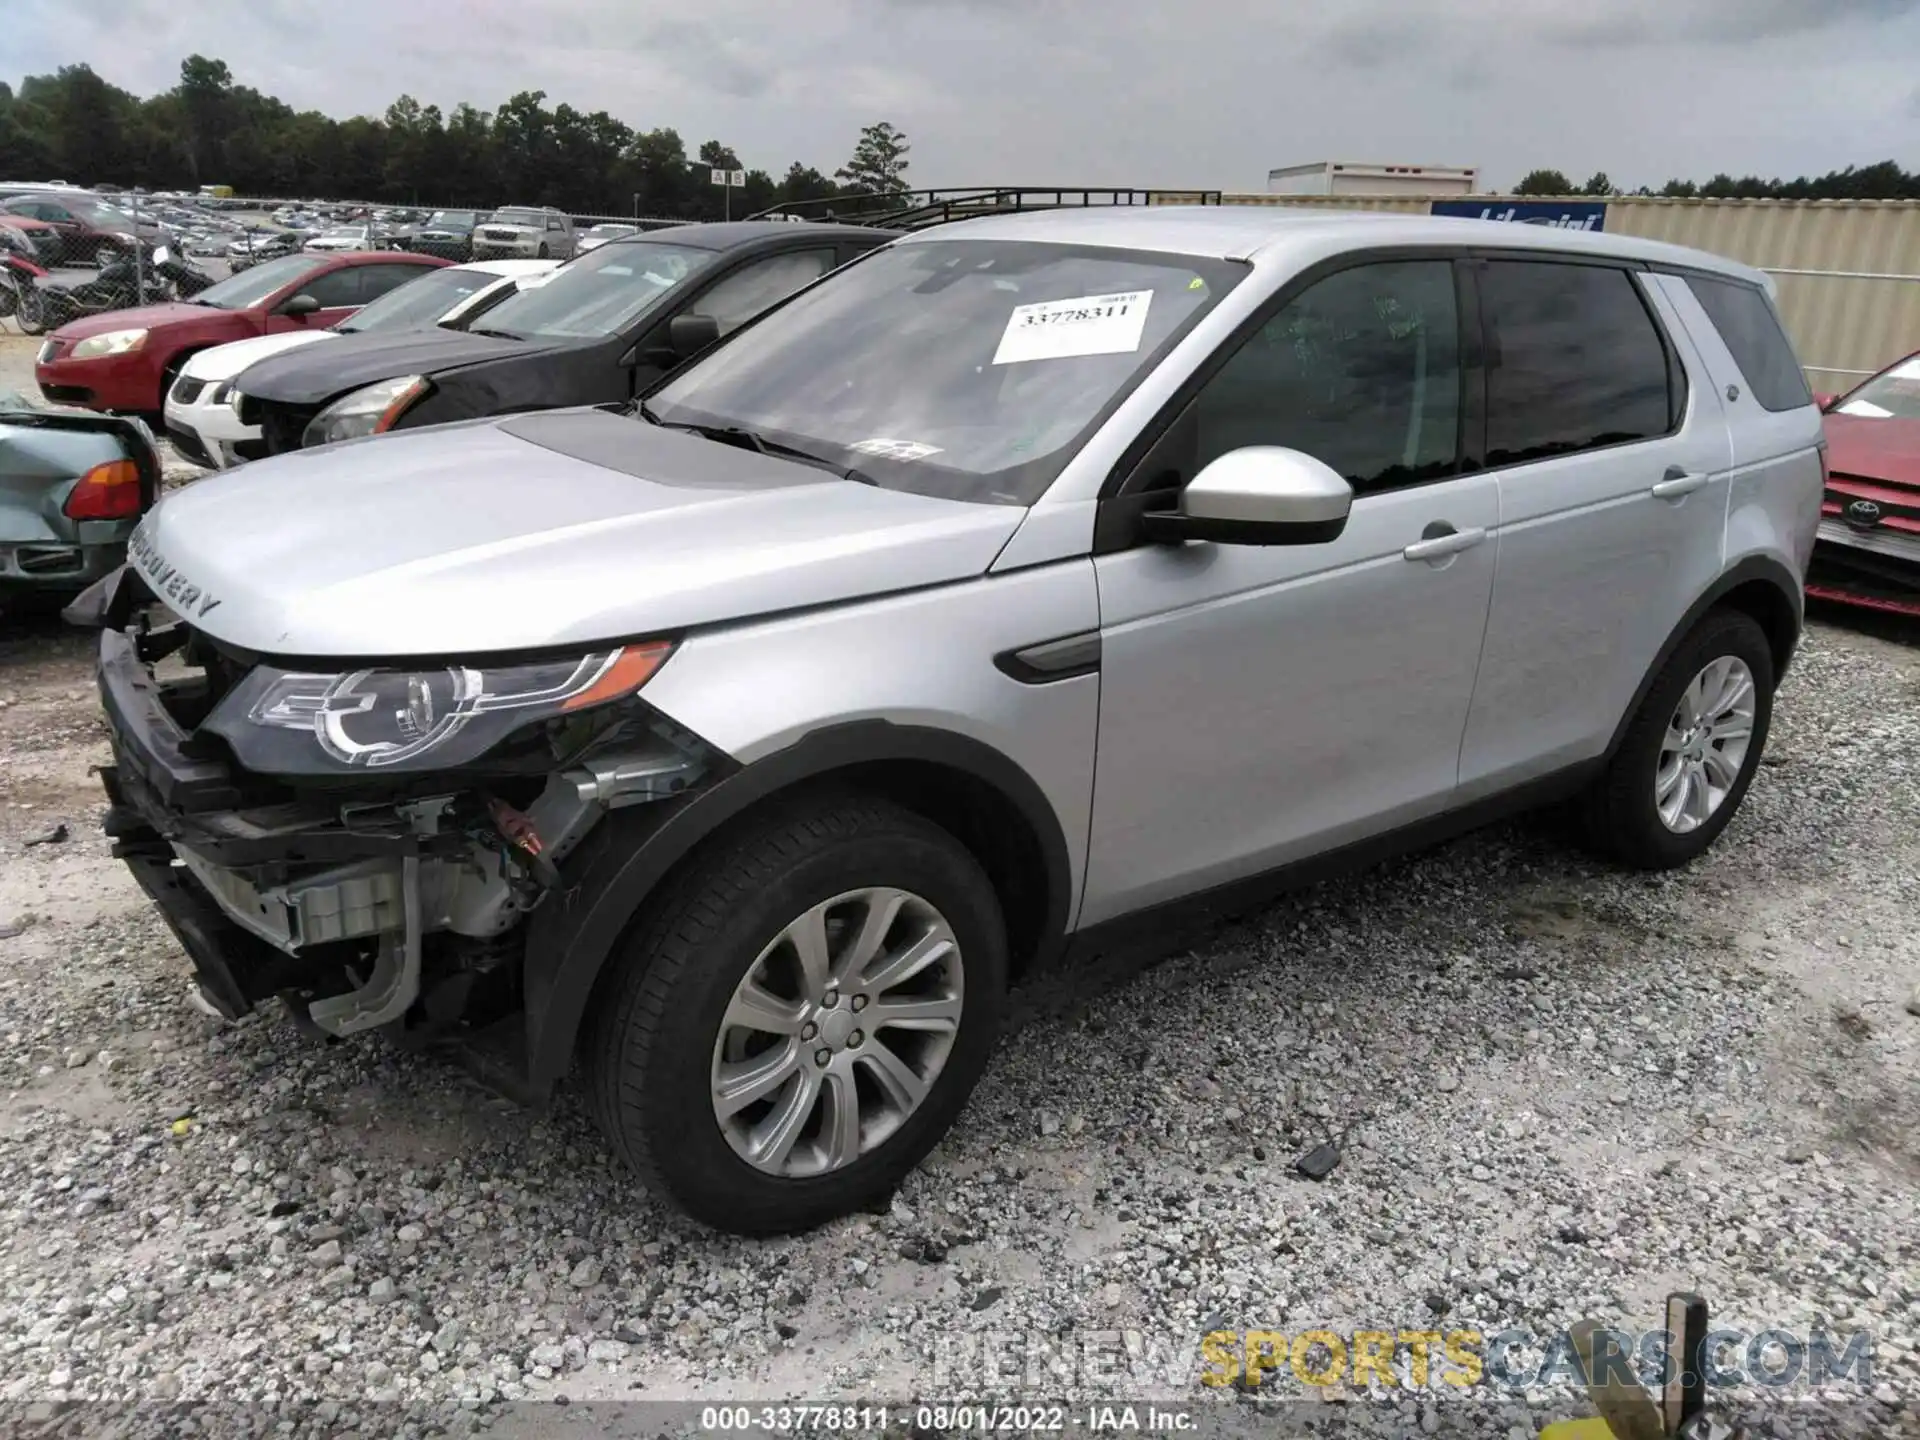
[1192, 261, 1461, 493]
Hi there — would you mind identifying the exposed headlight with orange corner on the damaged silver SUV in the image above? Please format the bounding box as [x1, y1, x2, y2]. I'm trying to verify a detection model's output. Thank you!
[207, 639, 674, 776]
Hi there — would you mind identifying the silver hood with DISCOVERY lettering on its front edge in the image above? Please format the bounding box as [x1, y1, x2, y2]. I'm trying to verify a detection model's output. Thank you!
[132, 409, 1025, 659]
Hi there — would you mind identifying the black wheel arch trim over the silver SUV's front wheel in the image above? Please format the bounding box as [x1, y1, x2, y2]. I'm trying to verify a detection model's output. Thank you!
[524, 720, 1073, 1096]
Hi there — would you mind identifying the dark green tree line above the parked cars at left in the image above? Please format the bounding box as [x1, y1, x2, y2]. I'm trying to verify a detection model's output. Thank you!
[0, 56, 908, 219]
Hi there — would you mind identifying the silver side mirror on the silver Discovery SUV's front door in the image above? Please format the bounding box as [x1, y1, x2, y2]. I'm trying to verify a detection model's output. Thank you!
[1140, 445, 1354, 545]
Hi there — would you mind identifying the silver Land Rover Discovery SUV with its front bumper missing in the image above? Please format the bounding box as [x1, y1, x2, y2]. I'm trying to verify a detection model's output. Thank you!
[77, 209, 1822, 1233]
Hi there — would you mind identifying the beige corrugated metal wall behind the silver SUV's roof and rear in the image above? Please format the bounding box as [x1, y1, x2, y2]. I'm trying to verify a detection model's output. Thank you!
[1198, 190, 1920, 392]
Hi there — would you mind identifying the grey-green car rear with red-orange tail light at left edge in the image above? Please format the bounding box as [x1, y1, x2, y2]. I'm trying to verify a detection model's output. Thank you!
[0, 392, 159, 612]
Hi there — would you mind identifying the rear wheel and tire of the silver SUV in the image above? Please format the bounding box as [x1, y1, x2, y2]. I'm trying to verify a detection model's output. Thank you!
[1586, 611, 1774, 870]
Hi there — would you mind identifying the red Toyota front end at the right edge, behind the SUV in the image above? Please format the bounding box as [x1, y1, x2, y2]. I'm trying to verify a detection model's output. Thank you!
[1807, 351, 1920, 616]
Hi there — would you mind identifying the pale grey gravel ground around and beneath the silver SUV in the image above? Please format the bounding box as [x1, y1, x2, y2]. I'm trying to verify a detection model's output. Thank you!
[0, 340, 1920, 1436]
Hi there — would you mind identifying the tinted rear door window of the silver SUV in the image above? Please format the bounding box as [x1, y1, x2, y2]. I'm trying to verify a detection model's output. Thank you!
[1480, 261, 1678, 465]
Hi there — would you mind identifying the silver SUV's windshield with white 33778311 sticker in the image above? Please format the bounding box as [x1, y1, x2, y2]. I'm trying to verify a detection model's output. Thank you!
[647, 240, 1246, 505]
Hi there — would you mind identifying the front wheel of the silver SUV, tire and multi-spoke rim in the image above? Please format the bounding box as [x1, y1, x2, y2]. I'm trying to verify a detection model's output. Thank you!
[584, 795, 1006, 1235]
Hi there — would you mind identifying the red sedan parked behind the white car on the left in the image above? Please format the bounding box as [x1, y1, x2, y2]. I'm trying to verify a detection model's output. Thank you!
[33, 252, 447, 424]
